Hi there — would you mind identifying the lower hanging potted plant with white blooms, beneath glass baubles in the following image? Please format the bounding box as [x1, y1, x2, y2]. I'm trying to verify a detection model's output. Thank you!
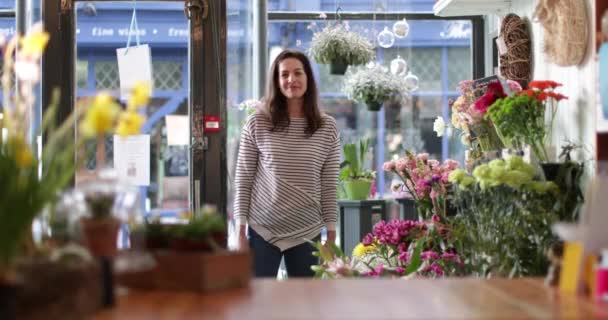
[343, 65, 406, 111]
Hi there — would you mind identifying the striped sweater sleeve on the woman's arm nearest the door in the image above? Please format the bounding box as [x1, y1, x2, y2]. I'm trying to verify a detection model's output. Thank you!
[234, 115, 259, 226]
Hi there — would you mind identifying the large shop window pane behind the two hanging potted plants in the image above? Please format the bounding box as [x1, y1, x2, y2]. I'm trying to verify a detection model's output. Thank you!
[268, 20, 472, 196]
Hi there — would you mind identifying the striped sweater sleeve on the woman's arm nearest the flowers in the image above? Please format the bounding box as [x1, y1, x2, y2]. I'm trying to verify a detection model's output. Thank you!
[321, 118, 340, 230]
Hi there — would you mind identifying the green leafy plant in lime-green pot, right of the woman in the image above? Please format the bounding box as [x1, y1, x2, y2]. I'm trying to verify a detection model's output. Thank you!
[340, 140, 375, 200]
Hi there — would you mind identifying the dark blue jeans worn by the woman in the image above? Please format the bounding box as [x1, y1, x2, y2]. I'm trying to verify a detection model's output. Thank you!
[248, 228, 320, 278]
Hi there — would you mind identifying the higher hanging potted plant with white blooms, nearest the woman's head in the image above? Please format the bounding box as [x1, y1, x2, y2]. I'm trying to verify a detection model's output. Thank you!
[309, 23, 375, 74]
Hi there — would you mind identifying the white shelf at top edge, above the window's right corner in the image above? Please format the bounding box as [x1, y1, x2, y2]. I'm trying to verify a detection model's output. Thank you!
[433, 0, 513, 17]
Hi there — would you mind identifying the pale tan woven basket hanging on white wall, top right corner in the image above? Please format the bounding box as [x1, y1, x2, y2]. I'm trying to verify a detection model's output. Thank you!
[534, 0, 590, 67]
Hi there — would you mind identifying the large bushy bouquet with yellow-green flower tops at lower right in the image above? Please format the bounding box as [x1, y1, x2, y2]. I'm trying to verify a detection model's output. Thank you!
[449, 156, 559, 277]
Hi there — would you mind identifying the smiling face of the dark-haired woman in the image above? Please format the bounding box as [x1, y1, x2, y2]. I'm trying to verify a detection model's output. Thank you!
[279, 58, 308, 99]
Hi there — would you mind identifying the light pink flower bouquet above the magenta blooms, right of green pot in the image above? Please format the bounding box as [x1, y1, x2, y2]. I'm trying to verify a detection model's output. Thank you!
[384, 151, 459, 218]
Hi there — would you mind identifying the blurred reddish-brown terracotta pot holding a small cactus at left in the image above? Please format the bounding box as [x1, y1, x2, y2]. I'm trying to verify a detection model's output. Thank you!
[80, 217, 120, 258]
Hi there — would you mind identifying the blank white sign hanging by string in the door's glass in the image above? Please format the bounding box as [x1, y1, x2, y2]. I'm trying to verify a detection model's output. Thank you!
[116, 44, 154, 101]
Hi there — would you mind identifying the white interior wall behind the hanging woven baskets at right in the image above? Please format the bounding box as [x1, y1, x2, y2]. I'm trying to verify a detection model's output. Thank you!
[488, 0, 597, 174]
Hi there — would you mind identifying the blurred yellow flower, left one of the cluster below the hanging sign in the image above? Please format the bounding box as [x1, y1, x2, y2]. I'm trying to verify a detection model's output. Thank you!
[81, 93, 120, 137]
